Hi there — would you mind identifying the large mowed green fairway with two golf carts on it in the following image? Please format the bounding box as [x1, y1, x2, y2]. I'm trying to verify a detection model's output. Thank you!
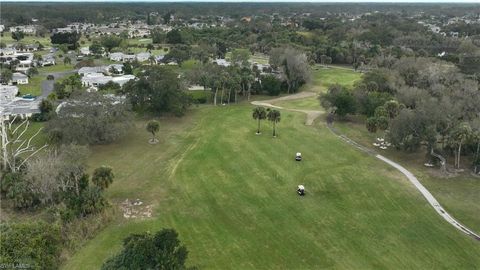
[63, 105, 480, 270]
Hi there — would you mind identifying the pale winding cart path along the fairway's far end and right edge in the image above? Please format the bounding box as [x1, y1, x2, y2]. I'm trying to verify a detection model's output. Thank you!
[251, 92, 480, 241]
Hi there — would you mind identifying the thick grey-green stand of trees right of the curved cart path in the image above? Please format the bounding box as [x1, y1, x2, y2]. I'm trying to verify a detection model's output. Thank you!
[321, 58, 480, 173]
